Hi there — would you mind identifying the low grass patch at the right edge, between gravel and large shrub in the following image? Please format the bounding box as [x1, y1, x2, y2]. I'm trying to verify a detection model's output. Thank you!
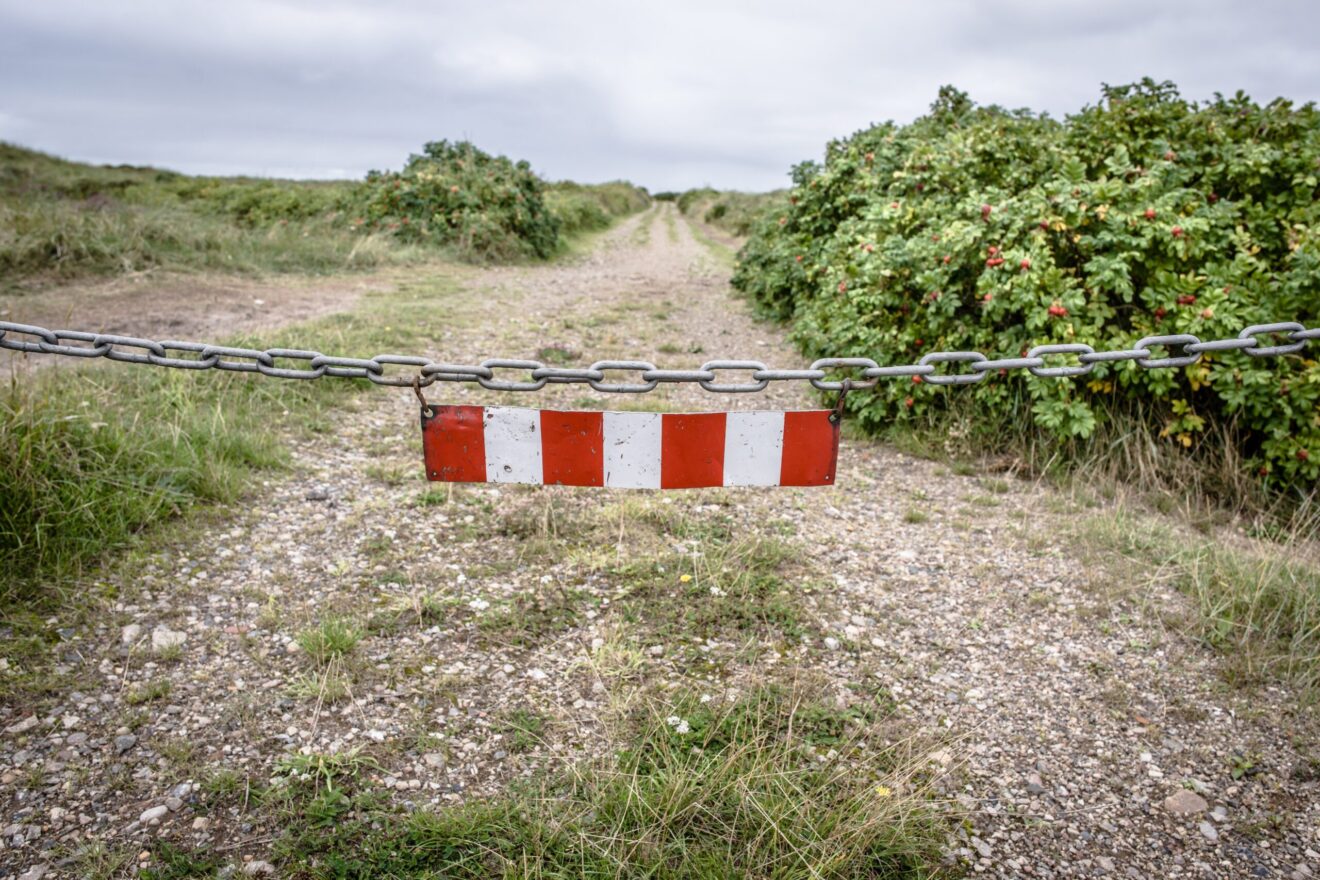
[1078, 511, 1320, 697]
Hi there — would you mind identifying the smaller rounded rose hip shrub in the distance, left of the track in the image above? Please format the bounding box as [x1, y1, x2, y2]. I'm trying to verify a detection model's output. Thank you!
[355, 141, 560, 263]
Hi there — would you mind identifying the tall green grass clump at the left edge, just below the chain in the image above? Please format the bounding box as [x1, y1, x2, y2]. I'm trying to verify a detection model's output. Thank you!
[0, 369, 284, 600]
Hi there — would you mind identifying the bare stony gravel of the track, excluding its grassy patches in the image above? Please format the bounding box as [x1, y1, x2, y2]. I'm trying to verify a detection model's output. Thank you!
[0, 204, 1320, 877]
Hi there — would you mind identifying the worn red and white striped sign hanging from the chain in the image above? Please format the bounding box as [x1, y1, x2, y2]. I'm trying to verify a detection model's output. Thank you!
[421, 405, 838, 489]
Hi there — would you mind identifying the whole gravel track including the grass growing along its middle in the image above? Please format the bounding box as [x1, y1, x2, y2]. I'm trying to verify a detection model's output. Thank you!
[0, 204, 1320, 877]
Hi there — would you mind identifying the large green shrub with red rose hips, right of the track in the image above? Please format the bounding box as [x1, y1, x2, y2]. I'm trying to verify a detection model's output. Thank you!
[734, 79, 1320, 486]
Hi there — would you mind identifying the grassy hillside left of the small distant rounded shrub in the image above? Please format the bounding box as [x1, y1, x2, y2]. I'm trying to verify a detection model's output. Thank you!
[0, 142, 428, 286]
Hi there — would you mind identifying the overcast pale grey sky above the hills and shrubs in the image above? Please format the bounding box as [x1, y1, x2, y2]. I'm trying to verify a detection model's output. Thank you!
[0, 0, 1320, 190]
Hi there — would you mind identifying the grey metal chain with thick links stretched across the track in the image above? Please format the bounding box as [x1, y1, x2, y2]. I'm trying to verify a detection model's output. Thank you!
[0, 321, 1320, 394]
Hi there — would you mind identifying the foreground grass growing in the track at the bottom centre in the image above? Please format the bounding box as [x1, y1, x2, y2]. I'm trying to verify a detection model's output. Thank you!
[165, 685, 950, 880]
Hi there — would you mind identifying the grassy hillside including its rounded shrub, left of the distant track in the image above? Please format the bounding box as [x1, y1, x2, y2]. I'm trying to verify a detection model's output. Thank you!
[0, 142, 649, 288]
